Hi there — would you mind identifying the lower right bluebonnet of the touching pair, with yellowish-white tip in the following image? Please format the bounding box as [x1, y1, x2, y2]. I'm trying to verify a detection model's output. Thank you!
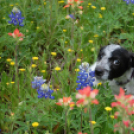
[37, 83, 54, 99]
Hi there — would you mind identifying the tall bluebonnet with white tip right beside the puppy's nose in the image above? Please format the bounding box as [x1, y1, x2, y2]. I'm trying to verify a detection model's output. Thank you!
[76, 62, 95, 90]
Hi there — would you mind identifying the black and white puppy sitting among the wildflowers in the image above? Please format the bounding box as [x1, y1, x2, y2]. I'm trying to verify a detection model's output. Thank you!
[91, 44, 134, 95]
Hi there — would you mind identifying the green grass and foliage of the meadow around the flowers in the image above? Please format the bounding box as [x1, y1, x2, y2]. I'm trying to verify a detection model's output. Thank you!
[0, 0, 134, 134]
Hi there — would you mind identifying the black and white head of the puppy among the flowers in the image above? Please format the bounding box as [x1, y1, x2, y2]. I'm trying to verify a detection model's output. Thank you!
[95, 44, 134, 80]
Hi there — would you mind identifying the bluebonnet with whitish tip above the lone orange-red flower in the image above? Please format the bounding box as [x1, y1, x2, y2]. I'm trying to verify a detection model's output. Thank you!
[8, 7, 24, 26]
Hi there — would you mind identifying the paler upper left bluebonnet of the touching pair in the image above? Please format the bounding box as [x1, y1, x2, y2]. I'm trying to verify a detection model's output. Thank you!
[32, 76, 46, 89]
